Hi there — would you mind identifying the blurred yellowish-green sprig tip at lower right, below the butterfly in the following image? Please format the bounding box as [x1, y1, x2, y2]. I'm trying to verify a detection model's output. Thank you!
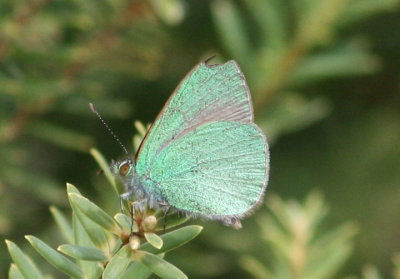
[241, 193, 356, 279]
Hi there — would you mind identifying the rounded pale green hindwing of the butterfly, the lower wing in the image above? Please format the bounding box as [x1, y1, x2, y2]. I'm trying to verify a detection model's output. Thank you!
[149, 121, 269, 220]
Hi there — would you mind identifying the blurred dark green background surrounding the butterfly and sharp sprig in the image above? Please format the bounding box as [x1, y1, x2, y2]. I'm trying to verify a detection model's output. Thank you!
[0, 0, 400, 278]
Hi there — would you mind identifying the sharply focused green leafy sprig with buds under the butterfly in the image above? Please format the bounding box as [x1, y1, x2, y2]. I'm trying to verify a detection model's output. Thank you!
[6, 144, 202, 279]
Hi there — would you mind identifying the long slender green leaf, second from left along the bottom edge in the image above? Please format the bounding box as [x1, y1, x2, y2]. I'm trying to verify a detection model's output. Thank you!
[25, 235, 84, 279]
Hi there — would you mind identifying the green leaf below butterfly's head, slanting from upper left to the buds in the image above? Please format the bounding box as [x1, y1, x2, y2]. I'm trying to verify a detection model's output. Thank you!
[69, 193, 122, 236]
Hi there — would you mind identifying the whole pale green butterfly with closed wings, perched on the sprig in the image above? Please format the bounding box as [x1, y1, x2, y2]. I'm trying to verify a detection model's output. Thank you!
[112, 59, 269, 227]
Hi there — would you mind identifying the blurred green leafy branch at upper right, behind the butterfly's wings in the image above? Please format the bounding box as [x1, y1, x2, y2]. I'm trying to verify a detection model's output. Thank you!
[211, 0, 398, 140]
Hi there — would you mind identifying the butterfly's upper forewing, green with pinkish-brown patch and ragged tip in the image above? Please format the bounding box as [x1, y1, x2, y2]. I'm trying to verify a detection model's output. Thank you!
[136, 61, 253, 174]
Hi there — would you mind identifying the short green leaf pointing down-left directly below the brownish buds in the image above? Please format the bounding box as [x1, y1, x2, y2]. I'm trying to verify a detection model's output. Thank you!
[103, 245, 132, 279]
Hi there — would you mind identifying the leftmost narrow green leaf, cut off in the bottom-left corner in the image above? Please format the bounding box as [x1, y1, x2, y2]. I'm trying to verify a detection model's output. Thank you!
[6, 240, 43, 279]
